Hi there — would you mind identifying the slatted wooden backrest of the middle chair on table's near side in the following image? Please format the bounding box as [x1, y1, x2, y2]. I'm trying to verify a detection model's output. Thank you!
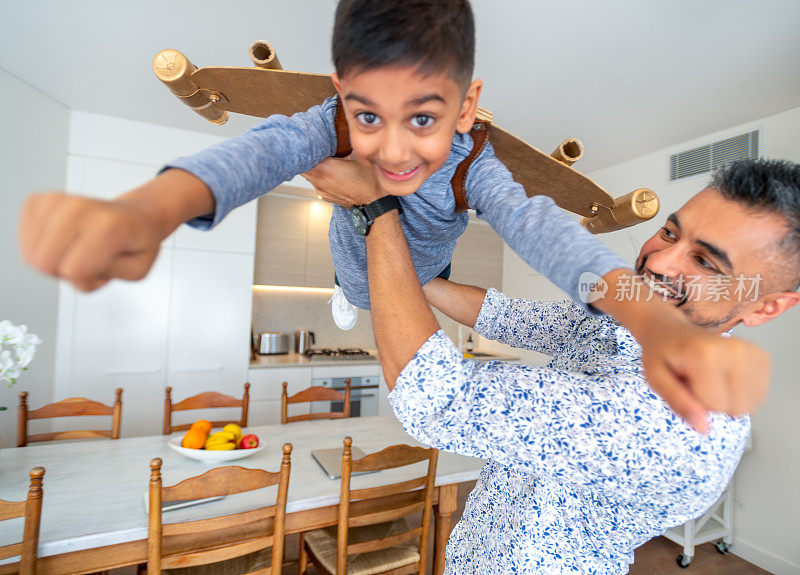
[147, 443, 292, 575]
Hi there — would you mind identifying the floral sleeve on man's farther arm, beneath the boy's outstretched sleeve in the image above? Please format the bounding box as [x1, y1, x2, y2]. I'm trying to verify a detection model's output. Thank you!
[475, 288, 587, 355]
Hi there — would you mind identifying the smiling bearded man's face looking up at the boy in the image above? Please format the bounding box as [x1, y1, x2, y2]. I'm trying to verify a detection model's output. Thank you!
[636, 188, 789, 332]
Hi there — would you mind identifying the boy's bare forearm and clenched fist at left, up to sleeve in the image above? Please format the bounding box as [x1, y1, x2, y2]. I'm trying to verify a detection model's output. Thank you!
[19, 170, 214, 291]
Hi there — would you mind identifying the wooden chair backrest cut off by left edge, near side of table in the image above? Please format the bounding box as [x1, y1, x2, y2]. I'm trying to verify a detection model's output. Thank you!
[0, 467, 44, 575]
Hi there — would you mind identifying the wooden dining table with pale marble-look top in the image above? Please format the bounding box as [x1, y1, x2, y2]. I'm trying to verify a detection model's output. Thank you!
[0, 416, 483, 575]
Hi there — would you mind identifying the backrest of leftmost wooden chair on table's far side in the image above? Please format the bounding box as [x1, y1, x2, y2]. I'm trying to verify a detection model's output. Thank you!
[17, 388, 122, 447]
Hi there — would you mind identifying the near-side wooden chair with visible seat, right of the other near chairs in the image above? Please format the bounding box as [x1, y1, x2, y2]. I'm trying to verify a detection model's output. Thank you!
[298, 437, 438, 575]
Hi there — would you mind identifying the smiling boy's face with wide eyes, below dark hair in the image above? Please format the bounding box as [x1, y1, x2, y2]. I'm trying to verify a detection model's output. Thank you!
[333, 66, 482, 196]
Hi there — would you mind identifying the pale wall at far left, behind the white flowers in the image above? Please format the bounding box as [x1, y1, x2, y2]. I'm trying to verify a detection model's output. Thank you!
[0, 69, 69, 447]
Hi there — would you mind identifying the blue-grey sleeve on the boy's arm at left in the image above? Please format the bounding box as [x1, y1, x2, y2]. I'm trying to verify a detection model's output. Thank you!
[162, 98, 337, 229]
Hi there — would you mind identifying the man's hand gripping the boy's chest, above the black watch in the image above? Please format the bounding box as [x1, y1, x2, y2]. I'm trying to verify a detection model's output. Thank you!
[303, 156, 386, 208]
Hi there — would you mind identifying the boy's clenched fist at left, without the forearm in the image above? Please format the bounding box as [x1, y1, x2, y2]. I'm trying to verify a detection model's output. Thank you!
[19, 192, 162, 291]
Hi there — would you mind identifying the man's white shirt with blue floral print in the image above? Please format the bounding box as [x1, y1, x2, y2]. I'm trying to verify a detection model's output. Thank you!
[389, 290, 750, 575]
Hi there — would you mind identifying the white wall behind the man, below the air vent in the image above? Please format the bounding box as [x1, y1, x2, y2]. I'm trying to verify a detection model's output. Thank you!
[503, 108, 800, 574]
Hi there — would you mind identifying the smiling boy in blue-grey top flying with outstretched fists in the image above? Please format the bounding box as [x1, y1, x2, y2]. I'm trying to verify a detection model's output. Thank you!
[22, 0, 766, 426]
